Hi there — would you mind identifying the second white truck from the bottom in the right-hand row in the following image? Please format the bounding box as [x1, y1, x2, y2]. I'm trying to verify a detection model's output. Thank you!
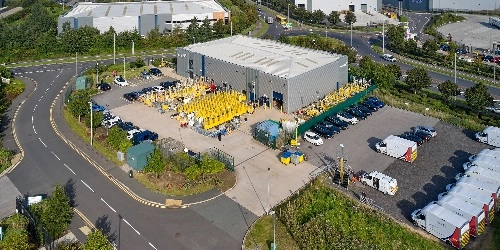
[431, 195, 486, 237]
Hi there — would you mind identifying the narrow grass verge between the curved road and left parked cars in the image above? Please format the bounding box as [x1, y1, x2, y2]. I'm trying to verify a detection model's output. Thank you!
[63, 109, 123, 166]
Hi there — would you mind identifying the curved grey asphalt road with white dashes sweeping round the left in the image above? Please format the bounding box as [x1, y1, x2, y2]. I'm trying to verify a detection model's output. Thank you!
[8, 62, 242, 250]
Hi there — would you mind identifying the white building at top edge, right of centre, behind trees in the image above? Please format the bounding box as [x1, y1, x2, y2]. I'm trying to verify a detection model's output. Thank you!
[292, 0, 382, 15]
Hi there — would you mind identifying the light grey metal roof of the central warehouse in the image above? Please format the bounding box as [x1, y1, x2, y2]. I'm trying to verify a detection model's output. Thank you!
[185, 35, 343, 78]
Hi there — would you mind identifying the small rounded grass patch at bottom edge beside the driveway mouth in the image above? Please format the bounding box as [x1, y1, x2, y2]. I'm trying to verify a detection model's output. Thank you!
[243, 215, 300, 250]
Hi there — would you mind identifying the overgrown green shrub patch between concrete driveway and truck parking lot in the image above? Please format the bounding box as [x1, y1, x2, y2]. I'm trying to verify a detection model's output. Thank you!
[276, 177, 442, 249]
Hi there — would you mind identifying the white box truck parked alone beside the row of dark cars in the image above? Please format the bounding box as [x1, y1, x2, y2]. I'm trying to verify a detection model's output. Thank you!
[375, 135, 417, 162]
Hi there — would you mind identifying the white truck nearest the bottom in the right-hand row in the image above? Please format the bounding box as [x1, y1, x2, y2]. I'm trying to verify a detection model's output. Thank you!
[411, 203, 470, 249]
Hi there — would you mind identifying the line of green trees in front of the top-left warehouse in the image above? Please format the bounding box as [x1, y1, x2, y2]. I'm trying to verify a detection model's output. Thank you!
[0, 0, 258, 63]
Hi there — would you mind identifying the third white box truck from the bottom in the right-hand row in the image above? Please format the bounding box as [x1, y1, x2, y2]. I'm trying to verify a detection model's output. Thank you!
[438, 186, 495, 224]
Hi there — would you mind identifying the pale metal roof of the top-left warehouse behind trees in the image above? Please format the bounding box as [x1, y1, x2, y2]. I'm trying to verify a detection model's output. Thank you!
[64, 0, 225, 17]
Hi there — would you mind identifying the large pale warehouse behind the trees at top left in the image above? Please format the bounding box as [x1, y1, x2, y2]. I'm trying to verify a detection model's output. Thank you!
[58, 0, 229, 36]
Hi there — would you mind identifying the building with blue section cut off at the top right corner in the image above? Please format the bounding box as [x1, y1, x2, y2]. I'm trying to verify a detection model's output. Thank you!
[382, 0, 500, 12]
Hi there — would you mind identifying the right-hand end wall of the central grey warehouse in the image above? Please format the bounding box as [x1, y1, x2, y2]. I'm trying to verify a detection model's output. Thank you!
[286, 56, 348, 112]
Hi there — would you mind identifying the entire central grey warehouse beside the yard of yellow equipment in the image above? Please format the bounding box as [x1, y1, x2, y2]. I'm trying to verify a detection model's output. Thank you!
[177, 35, 348, 112]
